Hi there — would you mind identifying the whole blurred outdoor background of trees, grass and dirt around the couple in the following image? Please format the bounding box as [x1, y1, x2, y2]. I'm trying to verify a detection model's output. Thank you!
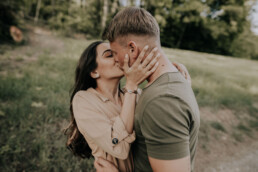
[0, 0, 258, 172]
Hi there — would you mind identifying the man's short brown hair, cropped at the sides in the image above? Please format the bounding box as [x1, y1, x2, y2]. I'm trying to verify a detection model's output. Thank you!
[102, 7, 159, 42]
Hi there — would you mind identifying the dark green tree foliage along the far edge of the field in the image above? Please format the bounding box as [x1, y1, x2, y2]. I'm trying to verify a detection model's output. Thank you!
[0, 0, 258, 59]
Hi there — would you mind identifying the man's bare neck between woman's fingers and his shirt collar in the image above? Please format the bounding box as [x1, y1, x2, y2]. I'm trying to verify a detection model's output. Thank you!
[146, 49, 178, 87]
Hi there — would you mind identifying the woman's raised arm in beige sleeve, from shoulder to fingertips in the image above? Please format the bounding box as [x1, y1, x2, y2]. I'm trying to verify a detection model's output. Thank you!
[73, 45, 158, 159]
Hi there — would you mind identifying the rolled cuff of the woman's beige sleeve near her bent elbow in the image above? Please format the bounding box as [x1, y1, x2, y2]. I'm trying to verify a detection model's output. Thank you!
[112, 116, 135, 145]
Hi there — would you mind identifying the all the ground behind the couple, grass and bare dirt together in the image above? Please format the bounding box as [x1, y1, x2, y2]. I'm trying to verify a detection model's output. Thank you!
[0, 26, 258, 172]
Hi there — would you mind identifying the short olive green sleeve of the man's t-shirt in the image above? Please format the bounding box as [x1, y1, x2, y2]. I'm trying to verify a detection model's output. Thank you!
[141, 96, 190, 160]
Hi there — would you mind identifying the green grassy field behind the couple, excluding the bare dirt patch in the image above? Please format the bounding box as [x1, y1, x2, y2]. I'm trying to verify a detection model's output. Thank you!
[0, 28, 258, 171]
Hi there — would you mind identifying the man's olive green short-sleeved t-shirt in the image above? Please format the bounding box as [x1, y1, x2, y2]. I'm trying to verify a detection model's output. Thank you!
[132, 72, 200, 172]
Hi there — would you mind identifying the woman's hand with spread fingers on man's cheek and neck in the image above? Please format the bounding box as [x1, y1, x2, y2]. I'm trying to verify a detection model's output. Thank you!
[123, 46, 160, 87]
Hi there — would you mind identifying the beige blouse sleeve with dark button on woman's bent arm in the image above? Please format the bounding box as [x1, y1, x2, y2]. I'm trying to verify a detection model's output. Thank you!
[73, 94, 135, 159]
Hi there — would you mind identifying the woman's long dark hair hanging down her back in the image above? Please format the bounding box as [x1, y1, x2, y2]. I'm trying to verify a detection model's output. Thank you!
[65, 41, 103, 158]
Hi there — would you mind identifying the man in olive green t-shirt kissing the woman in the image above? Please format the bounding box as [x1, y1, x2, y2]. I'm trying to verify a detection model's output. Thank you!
[95, 7, 200, 172]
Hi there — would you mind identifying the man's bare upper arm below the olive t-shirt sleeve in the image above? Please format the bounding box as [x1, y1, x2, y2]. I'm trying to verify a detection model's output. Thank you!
[148, 156, 191, 172]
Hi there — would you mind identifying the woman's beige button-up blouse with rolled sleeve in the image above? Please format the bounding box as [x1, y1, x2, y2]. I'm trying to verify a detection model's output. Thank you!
[72, 88, 135, 172]
